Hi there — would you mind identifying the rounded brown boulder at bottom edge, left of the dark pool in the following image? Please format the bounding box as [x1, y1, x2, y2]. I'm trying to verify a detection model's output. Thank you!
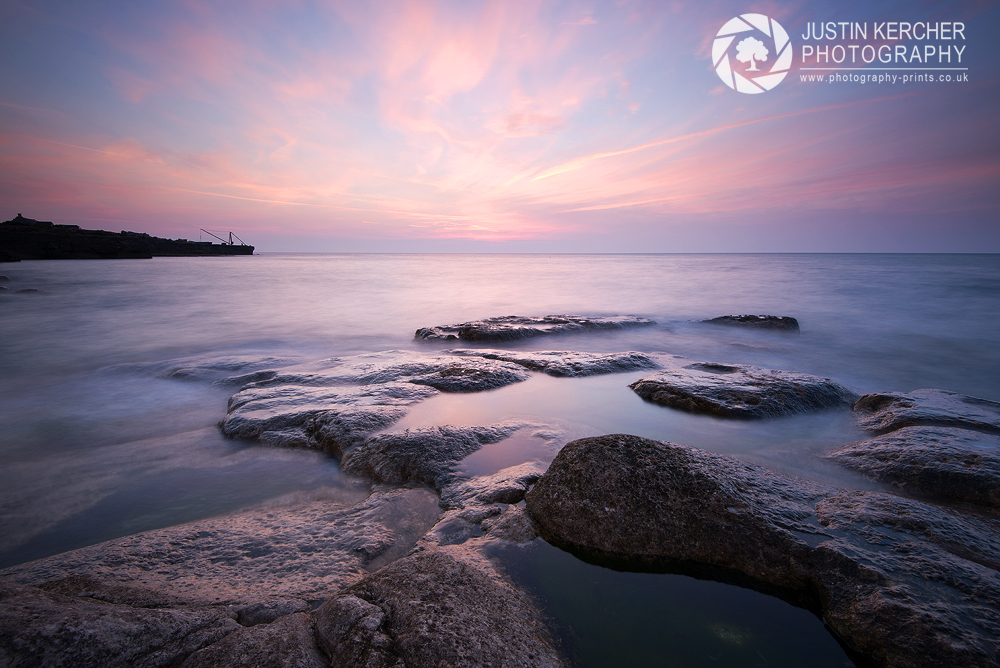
[314, 551, 563, 668]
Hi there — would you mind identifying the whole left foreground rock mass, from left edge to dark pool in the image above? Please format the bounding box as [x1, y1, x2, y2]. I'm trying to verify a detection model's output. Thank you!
[0, 464, 564, 668]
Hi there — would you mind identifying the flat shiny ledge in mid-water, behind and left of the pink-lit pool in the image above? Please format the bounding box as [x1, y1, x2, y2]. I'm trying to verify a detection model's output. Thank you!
[222, 350, 660, 458]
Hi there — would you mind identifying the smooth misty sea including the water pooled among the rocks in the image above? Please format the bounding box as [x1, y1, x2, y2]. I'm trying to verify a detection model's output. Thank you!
[0, 253, 1000, 666]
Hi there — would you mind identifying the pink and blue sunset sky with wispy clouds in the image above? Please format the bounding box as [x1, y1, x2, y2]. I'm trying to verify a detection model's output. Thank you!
[0, 0, 1000, 253]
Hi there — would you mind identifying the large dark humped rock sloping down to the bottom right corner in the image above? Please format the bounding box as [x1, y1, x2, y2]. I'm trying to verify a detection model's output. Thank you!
[526, 434, 1000, 668]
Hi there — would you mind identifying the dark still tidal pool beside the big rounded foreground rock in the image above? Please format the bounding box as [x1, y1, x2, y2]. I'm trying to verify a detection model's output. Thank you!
[490, 539, 856, 668]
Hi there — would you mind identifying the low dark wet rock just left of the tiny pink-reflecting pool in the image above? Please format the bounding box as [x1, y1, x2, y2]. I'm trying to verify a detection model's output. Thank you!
[340, 422, 532, 490]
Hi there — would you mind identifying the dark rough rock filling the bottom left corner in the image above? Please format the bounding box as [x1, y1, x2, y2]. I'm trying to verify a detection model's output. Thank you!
[0, 581, 240, 668]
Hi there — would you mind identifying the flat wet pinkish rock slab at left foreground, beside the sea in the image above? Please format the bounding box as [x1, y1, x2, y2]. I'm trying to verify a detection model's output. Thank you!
[0, 489, 441, 605]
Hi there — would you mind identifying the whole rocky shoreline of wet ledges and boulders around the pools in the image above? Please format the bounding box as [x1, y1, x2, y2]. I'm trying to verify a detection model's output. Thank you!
[0, 316, 1000, 668]
